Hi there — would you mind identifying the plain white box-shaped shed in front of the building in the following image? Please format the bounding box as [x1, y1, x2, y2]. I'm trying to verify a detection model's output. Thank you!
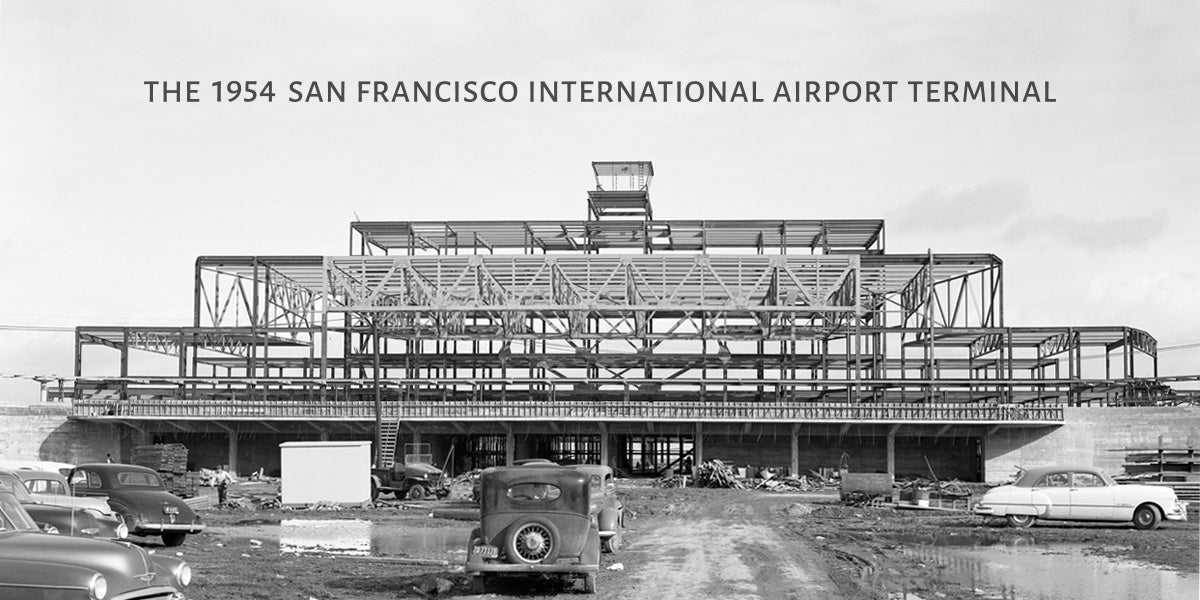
[280, 442, 371, 506]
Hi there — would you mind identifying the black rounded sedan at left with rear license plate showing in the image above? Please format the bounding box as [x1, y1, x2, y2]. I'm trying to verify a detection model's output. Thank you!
[67, 463, 205, 546]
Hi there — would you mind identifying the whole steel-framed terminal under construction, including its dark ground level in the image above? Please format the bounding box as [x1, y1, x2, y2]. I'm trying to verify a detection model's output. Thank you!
[65, 162, 1185, 479]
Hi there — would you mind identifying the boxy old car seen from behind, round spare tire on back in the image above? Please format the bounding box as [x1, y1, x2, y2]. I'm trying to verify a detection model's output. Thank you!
[467, 466, 600, 594]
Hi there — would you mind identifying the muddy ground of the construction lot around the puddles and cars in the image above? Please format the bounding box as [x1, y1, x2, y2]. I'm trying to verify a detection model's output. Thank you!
[171, 481, 1200, 600]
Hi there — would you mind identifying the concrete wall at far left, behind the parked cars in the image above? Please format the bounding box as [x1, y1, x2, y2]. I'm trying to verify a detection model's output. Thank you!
[0, 404, 122, 464]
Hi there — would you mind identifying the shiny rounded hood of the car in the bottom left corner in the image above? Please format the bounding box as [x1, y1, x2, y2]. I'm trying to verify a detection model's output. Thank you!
[0, 530, 159, 585]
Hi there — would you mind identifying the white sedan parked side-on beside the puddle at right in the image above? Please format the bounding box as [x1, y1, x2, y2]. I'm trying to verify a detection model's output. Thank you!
[974, 467, 1188, 529]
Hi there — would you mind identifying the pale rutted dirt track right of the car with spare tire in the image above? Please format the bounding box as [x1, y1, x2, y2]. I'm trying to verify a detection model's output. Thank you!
[623, 500, 841, 600]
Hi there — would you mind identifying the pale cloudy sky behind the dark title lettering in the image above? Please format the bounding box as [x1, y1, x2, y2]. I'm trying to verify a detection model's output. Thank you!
[0, 0, 1200, 402]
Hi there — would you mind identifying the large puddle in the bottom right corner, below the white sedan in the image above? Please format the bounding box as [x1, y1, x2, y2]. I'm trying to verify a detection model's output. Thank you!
[888, 538, 1200, 600]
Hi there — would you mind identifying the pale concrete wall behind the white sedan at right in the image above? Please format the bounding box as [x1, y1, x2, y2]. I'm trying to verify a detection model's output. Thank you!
[984, 407, 1200, 481]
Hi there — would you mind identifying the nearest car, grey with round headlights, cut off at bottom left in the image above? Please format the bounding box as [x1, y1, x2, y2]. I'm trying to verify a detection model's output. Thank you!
[0, 491, 192, 600]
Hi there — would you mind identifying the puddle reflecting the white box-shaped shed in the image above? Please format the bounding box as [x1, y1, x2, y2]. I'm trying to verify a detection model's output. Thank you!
[214, 518, 470, 563]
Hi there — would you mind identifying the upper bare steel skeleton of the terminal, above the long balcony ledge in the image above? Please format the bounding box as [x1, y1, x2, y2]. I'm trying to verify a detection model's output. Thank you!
[74, 162, 1170, 420]
